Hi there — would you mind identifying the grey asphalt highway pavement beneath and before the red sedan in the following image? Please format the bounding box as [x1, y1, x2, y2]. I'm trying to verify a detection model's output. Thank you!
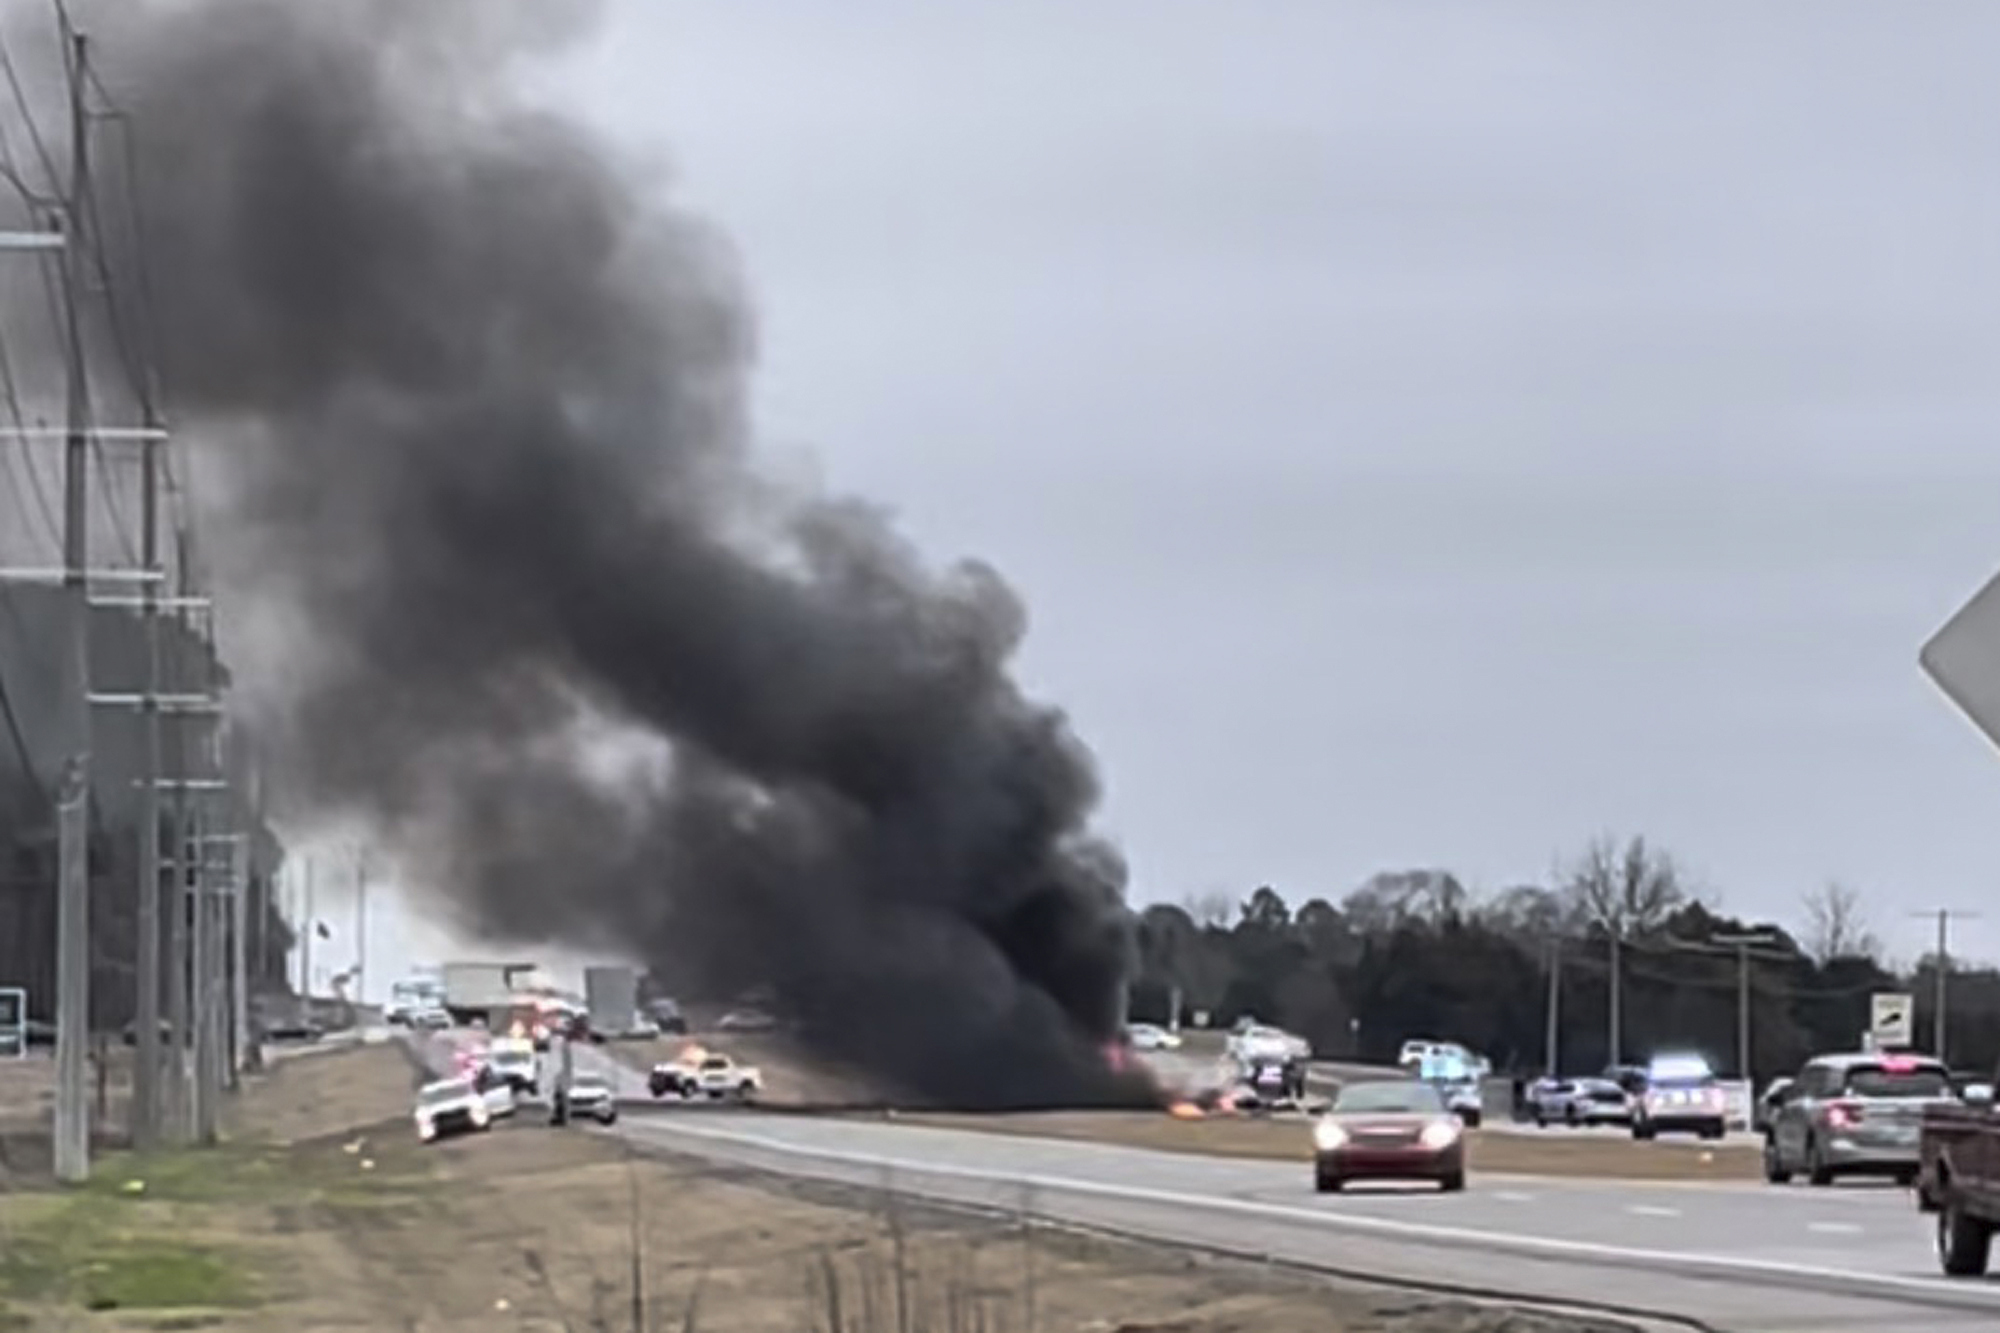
[620, 1111, 2000, 1333]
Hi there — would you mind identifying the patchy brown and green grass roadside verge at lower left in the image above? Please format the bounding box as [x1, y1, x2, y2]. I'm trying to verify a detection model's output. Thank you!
[0, 1049, 1618, 1333]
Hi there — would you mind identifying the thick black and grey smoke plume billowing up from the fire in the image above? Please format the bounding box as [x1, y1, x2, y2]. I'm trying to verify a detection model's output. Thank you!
[39, 0, 1130, 1105]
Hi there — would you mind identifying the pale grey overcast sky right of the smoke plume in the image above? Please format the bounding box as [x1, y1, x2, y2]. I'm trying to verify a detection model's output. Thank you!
[336, 0, 2000, 975]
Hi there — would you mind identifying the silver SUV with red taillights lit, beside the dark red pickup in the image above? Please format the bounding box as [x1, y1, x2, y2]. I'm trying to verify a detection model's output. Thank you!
[1764, 1051, 1954, 1185]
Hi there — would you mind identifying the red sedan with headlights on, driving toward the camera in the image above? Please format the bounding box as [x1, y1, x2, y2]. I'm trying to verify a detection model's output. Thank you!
[1312, 1079, 1466, 1193]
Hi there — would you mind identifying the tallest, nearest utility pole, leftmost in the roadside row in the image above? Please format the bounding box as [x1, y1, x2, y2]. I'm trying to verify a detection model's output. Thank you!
[54, 23, 90, 1185]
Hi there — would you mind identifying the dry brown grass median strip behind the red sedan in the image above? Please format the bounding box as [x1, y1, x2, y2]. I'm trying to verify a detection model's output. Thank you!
[898, 1111, 1762, 1181]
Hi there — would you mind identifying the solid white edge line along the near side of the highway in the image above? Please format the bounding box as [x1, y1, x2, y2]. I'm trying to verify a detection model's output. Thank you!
[626, 1121, 2000, 1307]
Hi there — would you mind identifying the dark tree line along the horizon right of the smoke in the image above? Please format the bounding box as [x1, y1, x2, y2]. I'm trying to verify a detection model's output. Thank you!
[1130, 837, 2000, 1081]
